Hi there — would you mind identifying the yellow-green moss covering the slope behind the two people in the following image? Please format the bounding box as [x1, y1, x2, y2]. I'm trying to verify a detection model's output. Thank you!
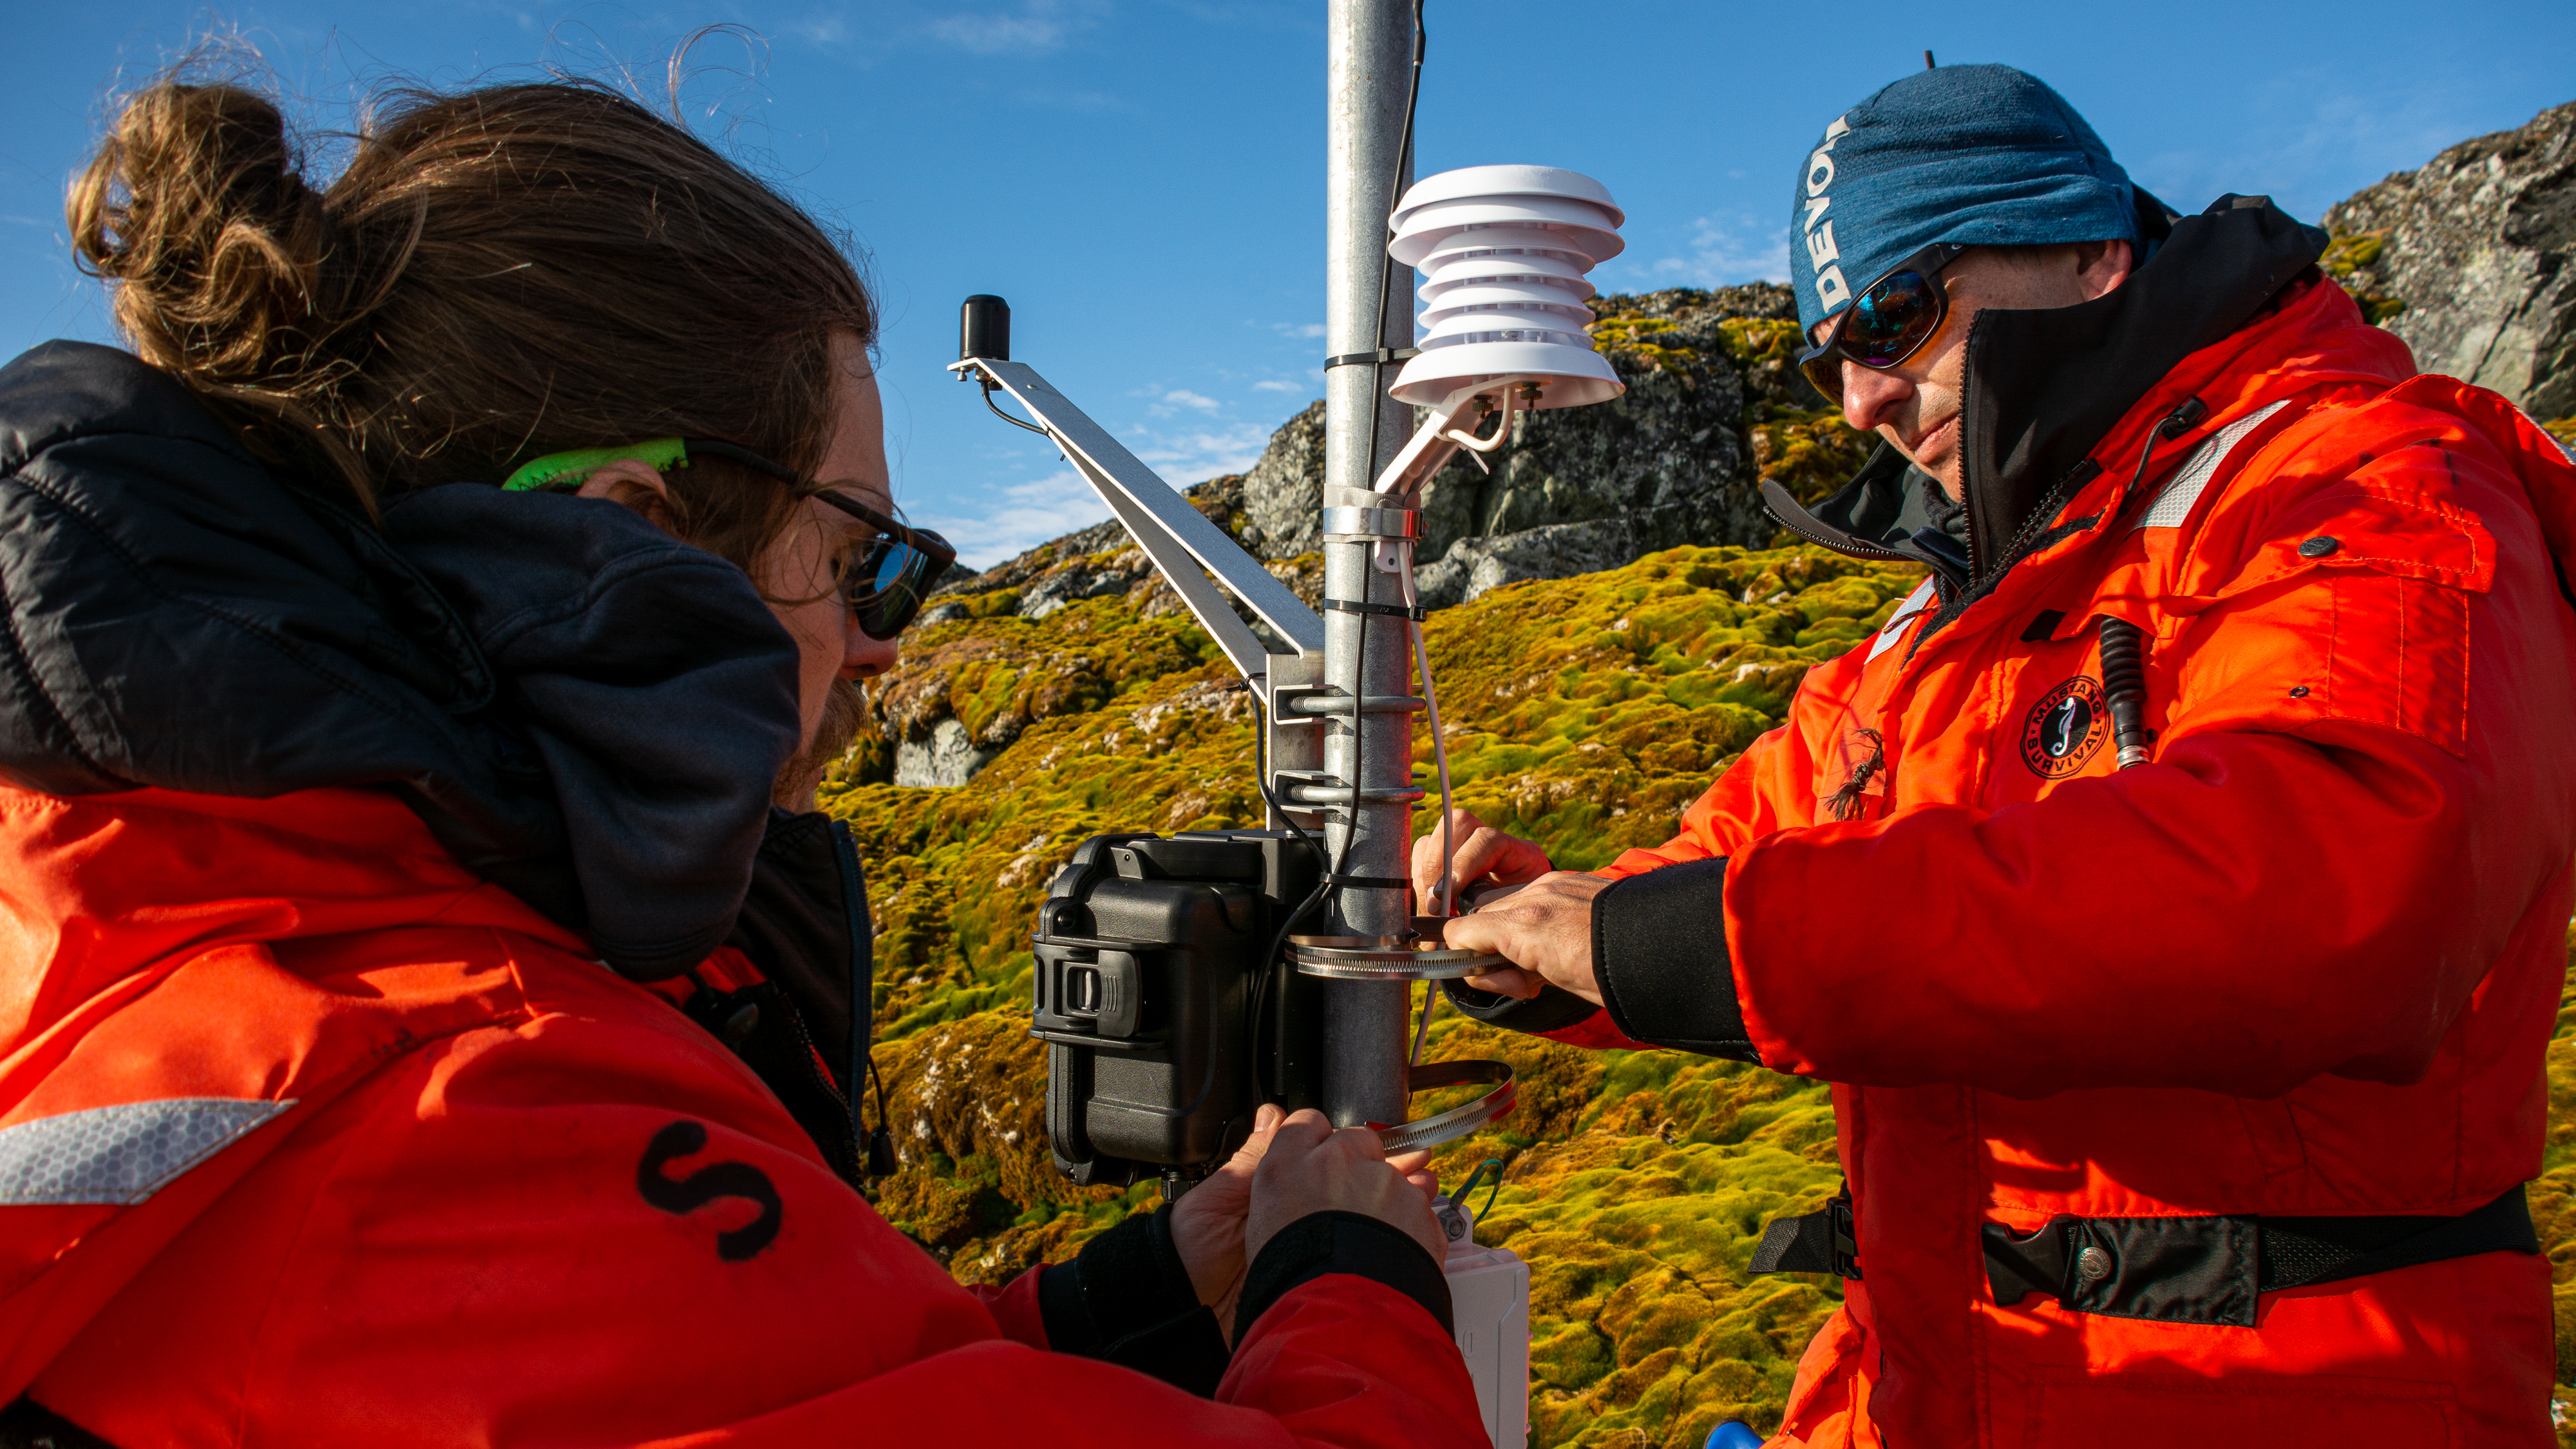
[824, 538, 2576, 1449]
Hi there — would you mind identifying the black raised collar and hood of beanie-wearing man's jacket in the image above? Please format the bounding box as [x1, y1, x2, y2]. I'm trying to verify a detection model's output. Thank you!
[1762, 196, 2326, 585]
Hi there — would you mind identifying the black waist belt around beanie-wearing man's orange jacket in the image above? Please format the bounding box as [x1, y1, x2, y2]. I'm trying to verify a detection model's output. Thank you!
[1752, 1186, 2540, 1328]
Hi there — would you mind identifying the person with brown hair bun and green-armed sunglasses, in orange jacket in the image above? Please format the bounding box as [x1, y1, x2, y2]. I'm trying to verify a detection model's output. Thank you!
[0, 80, 1484, 1449]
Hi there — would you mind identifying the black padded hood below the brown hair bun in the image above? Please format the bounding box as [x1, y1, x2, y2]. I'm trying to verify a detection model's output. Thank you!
[0, 343, 799, 980]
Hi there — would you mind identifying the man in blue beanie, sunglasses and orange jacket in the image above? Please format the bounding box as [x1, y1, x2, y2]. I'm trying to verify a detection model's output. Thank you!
[1414, 67, 2576, 1449]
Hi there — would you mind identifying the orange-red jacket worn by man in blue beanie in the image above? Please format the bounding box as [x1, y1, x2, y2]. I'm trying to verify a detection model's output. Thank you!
[1551, 273, 2576, 1449]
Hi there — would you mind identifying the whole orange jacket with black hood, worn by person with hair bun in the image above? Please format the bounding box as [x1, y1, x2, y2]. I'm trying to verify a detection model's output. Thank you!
[0, 332, 1481, 1449]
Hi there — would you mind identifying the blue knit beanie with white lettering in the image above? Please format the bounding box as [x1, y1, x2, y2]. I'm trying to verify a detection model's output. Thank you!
[1788, 64, 2138, 335]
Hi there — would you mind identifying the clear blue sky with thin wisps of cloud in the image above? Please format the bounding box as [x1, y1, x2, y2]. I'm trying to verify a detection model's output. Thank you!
[0, 0, 2576, 562]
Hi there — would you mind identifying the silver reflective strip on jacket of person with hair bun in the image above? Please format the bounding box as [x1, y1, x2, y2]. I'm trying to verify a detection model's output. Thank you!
[0, 1096, 294, 1207]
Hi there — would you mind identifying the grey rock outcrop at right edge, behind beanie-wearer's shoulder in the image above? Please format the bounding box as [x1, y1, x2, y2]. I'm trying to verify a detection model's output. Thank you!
[2326, 103, 2576, 421]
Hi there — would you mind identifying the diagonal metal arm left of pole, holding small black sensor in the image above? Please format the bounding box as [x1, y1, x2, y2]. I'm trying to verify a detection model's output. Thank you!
[951, 358, 1324, 699]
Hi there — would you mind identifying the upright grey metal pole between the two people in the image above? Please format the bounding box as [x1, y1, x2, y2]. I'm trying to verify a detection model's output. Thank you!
[1319, 0, 1414, 1127]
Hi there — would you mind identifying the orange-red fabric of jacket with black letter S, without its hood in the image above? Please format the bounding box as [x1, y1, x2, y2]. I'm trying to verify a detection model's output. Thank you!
[0, 786, 1481, 1449]
